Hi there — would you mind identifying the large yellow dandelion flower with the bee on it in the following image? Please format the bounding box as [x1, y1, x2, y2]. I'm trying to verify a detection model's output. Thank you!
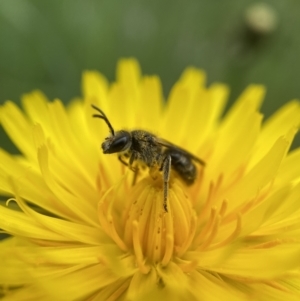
[0, 60, 300, 301]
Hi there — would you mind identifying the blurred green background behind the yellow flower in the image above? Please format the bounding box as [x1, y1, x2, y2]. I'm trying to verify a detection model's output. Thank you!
[0, 0, 300, 151]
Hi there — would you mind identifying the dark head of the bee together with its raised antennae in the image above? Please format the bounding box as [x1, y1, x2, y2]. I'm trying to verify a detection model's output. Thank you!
[92, 105, 131, 154]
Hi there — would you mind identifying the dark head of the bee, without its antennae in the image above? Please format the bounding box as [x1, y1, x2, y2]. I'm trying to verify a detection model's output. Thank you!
[101, 131, 131, 154]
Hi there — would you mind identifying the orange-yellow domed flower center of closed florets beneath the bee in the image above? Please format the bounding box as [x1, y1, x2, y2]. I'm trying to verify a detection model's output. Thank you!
[99, 177, 196, 273]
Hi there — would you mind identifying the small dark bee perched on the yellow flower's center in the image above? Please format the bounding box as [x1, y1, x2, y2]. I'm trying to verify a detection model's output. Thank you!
[92, 105, 205, 212]
